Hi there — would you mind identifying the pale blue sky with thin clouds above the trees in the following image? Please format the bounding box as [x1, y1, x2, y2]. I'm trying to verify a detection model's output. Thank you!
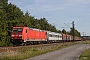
[8, 0, 90, 36]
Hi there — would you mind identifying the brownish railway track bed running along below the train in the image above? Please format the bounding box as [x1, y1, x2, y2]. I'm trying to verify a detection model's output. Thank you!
[0, 42, 72, 53]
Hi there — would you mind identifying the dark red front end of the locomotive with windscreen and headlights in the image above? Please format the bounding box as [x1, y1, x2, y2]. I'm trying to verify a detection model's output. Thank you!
[11, 27, 23, 44]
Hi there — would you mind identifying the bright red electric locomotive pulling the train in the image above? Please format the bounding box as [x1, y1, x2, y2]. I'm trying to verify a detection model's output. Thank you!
[11, 26, 47, 43]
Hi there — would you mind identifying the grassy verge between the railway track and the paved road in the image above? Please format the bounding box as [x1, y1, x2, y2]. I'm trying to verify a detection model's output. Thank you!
[0, 42, 89, 60]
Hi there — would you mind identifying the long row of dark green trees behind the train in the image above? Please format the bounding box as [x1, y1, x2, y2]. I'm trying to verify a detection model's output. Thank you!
[0, 0, 80, 46]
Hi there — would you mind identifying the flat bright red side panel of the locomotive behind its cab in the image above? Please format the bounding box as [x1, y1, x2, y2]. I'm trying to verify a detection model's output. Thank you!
[27, 29, 47, 41]
